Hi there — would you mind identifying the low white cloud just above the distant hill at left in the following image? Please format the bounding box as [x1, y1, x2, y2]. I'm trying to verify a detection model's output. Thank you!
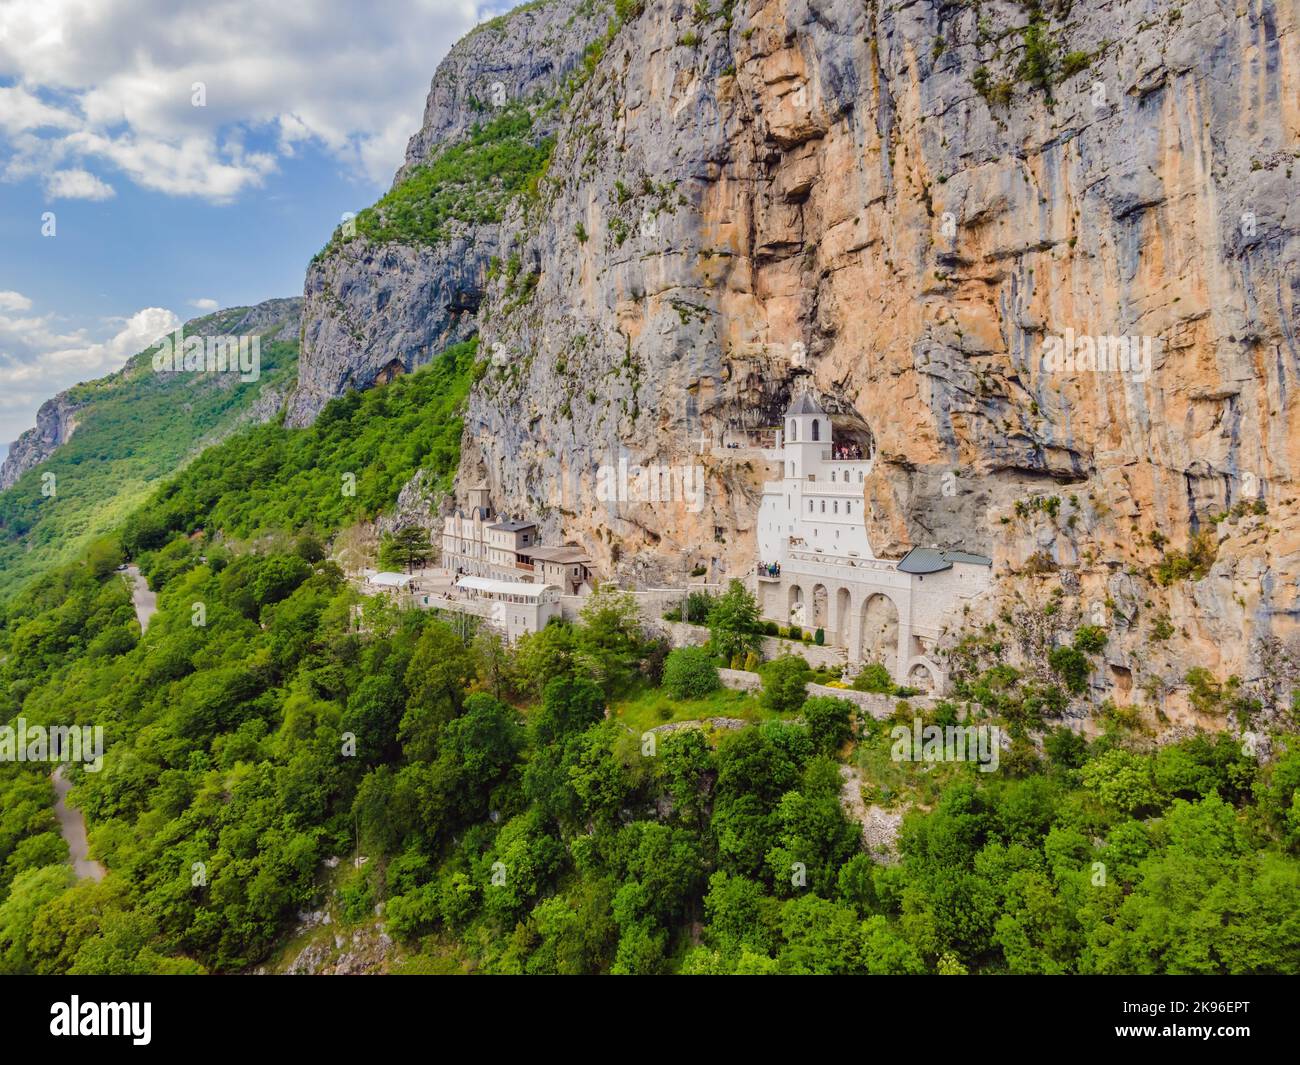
[0, 304, 181, 441]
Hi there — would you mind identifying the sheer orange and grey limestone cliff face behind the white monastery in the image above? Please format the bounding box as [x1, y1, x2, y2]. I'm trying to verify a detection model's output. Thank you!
[297, 0, 1300, 720]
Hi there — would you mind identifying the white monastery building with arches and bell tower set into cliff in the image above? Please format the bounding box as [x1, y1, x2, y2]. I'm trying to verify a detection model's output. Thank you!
[757, 394, 992, 690]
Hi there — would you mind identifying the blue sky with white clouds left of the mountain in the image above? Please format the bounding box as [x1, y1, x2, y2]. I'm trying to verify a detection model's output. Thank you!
[0, 0, 514, 455]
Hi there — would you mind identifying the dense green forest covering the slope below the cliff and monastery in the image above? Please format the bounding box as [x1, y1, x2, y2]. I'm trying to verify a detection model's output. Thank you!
[0, 343, 1300, 974]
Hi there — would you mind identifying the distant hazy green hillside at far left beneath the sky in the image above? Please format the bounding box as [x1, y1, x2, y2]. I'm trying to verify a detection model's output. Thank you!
[0, 307, 298, 599]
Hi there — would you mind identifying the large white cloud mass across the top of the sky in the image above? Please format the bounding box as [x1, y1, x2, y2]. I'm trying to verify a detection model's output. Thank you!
[0, 0, 488, 202]
